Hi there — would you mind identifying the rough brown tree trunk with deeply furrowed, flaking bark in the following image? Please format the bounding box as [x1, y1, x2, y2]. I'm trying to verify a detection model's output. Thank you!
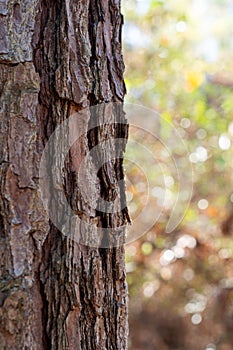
[0, 0, 129, 350]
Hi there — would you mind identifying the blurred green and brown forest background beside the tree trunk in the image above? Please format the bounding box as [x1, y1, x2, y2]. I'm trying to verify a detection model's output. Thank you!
[122, 0, 233, 350]
